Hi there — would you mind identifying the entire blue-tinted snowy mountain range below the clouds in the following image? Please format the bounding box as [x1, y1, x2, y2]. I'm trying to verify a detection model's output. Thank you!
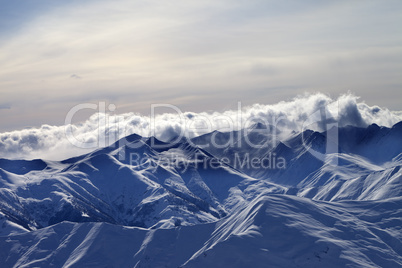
[0, 122, 402, 267]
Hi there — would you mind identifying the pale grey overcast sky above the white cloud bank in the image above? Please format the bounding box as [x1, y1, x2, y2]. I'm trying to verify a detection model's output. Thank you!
[0, 0, 402, 132]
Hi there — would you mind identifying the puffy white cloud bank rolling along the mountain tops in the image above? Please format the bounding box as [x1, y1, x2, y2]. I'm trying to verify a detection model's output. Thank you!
[0, 94, 402, 160]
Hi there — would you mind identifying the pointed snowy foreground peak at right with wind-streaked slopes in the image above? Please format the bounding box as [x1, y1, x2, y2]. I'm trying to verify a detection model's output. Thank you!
[185, 195, 402, 267]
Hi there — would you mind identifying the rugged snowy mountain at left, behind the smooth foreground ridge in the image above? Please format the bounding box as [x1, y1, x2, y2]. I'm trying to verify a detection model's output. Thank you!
[0, 135, 286, 231]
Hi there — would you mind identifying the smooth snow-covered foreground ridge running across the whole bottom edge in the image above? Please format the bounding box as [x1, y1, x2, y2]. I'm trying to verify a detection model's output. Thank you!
[0, 193, 402, 267]
